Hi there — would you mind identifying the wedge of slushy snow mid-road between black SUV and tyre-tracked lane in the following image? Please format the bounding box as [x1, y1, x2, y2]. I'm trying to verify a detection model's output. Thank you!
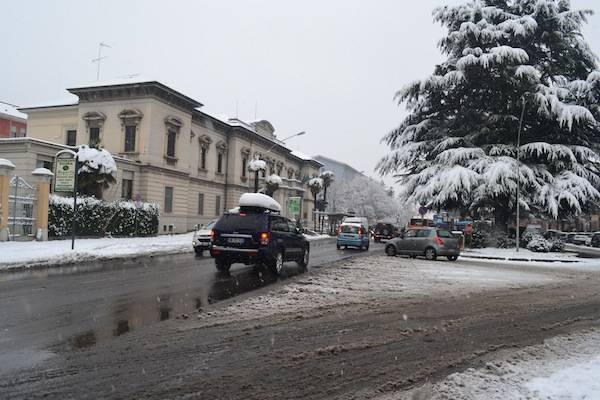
[191, 256, 558, 326]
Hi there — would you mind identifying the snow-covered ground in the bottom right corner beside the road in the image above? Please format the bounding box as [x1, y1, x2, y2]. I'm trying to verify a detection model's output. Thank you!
[386, 330, 600, 400]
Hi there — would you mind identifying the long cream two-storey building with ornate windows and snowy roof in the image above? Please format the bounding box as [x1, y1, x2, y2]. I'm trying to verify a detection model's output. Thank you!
[0, 81, 321, 233]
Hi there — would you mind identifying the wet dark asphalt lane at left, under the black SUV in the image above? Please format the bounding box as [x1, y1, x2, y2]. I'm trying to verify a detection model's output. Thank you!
[0, 241, 382, 375]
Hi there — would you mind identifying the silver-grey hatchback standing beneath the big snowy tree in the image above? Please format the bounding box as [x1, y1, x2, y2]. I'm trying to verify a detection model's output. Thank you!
[385, 227, 460, 261]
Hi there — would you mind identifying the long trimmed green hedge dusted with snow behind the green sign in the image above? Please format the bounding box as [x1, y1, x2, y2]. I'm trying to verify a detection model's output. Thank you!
[48, 195, 160, 238]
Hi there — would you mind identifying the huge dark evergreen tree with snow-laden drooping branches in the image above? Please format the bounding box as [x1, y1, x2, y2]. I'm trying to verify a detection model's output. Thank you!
[378, 0, 600, 226]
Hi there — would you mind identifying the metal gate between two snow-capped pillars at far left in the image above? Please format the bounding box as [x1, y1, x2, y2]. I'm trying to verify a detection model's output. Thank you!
[8, 176, 36, 240]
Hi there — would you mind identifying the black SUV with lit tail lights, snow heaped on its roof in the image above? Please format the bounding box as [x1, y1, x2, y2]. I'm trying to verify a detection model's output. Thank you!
[210, 207, 310, 274]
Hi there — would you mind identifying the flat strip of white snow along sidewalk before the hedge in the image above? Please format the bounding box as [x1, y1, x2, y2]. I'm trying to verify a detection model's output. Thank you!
[0, 233, 193, 270]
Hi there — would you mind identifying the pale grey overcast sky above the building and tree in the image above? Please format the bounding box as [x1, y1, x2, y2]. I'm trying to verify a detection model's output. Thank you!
[0, 0, 600, 185]
